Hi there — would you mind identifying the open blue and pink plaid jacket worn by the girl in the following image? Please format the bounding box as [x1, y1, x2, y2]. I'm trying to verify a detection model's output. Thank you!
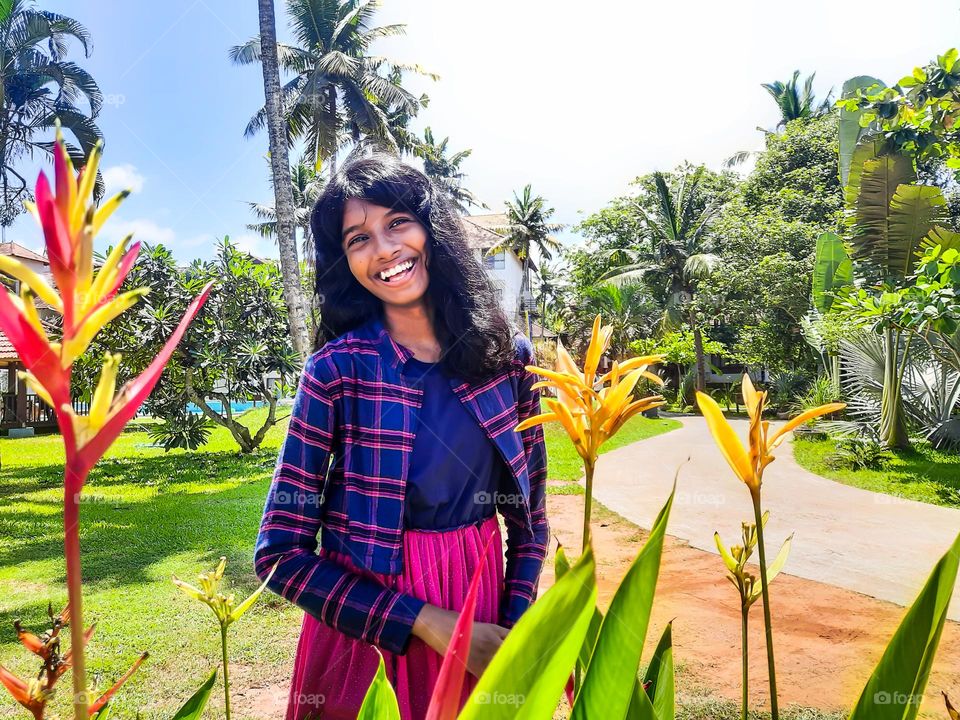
[254, 318, 549, 654]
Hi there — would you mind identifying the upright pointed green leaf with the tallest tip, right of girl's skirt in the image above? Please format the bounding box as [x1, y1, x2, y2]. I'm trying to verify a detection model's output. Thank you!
[571, 485, 676, 720]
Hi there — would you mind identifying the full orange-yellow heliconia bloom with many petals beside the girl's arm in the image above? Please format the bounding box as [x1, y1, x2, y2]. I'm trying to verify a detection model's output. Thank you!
[515, 315, 663, 463]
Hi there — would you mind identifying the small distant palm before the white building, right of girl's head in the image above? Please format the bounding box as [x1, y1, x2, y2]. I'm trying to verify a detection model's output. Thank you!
[487, 184, 564, 336]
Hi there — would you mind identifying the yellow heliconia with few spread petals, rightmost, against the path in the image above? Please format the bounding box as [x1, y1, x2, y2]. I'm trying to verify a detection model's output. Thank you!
[697, 373, 847, 493]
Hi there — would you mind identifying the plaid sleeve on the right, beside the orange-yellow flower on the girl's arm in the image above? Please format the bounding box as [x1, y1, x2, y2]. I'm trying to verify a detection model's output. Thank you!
[500, 336, 550, 627]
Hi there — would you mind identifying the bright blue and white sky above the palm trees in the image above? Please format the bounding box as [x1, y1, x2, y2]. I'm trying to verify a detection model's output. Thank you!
[6, 0, 960, 261]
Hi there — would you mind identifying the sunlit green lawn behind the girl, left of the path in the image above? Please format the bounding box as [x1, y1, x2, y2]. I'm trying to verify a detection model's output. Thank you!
[0, 409, 678, 720]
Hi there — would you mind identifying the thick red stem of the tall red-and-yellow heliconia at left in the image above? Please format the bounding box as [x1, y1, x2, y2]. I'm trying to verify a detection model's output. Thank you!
[63, 463, 89, 720]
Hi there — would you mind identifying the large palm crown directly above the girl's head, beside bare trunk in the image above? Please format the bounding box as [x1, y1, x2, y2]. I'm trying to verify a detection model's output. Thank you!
[230, 0, 437, 171]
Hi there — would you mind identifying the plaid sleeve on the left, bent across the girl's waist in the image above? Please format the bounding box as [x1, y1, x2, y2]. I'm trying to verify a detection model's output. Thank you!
[254, 354, 425, 654]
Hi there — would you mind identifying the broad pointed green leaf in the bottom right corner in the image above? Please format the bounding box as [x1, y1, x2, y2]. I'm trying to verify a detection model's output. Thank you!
[850, 535, 960, 720]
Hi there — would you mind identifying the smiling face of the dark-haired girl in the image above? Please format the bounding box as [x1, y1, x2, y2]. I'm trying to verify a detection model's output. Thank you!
[341, 198, 430, 306]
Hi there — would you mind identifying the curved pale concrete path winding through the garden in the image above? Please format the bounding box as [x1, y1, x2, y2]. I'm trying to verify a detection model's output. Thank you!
[580, 417, 960, 620]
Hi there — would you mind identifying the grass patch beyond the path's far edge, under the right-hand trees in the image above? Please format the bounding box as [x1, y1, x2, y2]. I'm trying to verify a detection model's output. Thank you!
[793, 438, 960, 507]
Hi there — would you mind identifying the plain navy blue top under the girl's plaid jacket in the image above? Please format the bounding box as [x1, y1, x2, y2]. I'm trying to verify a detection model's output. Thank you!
[403, 358, 505, 530]
